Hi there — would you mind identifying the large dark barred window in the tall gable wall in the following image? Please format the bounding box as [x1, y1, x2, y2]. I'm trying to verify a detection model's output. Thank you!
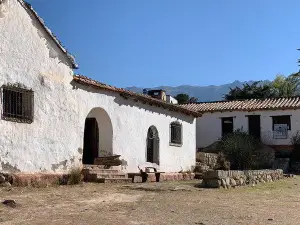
[2, 85, 34, 123]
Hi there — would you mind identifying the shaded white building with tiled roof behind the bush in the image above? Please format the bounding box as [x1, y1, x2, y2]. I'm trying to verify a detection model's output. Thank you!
[183, 97, 300, 149]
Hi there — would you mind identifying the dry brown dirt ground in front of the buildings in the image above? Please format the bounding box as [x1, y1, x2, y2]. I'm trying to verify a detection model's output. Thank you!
[0, 178, 300, 225]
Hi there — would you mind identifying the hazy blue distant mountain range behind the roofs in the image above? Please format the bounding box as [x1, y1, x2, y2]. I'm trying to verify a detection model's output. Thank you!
[126, 81, 254, 102]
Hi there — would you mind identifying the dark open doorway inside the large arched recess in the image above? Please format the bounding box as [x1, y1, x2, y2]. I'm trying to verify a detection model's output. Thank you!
[82, 118, 99, 164]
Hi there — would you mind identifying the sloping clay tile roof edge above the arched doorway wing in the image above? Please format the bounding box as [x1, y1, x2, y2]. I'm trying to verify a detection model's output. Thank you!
[73, 75, 201, 117]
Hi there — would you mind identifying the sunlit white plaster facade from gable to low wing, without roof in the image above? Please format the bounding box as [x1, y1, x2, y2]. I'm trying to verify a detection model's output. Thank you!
[0, 0, 196, 172]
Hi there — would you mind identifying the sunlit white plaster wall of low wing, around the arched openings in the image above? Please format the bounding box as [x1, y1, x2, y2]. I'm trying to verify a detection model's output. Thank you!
[75, 84, 196, 172]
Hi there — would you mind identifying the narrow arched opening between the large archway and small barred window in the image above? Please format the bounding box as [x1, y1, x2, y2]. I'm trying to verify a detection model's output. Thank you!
[147, 126, 159, 165]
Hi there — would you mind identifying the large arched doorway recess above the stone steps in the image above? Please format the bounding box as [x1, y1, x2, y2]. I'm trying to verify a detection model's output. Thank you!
[82, 108, 113, 164]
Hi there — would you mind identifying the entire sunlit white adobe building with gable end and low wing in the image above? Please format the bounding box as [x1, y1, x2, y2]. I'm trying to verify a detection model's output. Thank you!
[0, 0, 200, 172]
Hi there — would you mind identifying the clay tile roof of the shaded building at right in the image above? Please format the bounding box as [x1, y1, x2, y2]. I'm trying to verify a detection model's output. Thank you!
[181, 97, 300, 113]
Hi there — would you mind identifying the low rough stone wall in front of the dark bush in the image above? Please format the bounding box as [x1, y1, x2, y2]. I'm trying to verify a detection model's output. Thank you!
[202, 169, 283, 188]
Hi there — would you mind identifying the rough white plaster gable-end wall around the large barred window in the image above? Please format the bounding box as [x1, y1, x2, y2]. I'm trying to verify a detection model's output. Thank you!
[0, 0, 81, 171]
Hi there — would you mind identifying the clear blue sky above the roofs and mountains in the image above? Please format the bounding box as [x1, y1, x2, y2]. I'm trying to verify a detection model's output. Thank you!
[28, 0, 300, 87]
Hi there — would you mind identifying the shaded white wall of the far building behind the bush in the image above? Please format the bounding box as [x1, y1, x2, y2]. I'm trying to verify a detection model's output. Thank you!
[196, 109, 300, 148]
